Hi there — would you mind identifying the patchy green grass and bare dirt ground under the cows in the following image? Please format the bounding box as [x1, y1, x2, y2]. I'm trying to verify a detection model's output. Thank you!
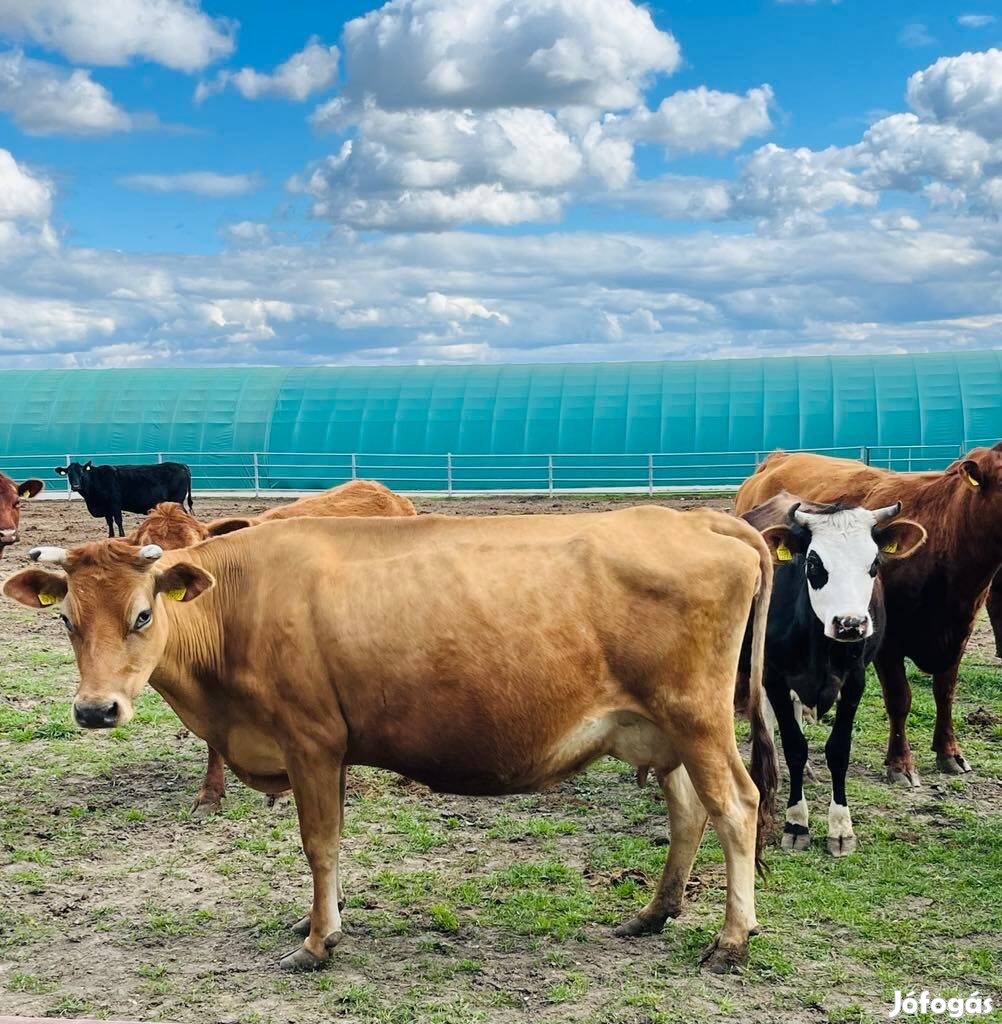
[0, 499, 1002, 1024]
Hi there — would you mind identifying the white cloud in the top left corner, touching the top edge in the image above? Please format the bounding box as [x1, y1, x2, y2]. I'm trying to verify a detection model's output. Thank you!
[0, 0, 233, 72]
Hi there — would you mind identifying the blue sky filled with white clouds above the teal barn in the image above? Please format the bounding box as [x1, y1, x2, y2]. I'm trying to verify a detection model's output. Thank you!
[0, 0, 1002, 366]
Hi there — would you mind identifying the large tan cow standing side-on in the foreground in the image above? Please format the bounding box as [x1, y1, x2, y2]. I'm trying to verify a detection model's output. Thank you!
[3, 508, 776, 970]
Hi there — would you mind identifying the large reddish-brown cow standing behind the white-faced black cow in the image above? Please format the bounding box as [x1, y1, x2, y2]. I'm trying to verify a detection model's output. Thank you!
[735, 444, 1002, 786]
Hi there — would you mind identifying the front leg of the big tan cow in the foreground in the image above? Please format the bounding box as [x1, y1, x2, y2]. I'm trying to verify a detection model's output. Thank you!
[279, 758, 344, 971]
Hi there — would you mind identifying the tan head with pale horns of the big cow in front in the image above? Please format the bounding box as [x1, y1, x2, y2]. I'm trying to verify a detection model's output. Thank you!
[3, 541, 215, 729]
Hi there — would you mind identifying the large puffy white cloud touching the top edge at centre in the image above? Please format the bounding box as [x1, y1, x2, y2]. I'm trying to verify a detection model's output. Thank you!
[344, 0, 681, 110]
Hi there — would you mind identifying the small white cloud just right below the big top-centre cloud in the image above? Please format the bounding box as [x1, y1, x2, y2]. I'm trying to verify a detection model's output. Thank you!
[613, 85, 774, 156]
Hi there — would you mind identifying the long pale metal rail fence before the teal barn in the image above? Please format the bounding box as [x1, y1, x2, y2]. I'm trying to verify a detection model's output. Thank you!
[2, 441, 992, 497]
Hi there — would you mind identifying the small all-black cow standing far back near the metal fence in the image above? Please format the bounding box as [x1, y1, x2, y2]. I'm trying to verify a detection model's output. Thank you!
[55, 462, 193, 537]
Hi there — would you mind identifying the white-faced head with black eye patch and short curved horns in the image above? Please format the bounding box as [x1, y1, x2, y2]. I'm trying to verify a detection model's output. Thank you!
[763, 502, 926, 643]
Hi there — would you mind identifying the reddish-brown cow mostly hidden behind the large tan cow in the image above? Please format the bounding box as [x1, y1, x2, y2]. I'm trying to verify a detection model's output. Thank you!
[125, 480, 417, 814]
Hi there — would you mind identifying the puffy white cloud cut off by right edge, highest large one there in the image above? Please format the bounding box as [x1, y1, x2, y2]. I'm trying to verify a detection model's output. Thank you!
[908, 49, 1002, 139]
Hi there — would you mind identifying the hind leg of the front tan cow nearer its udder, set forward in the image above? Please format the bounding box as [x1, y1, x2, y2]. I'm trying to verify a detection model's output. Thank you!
[614, 768, 707, 936]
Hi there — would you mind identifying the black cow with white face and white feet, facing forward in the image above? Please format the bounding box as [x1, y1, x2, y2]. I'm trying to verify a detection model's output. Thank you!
[742, 492, 926, 857]
